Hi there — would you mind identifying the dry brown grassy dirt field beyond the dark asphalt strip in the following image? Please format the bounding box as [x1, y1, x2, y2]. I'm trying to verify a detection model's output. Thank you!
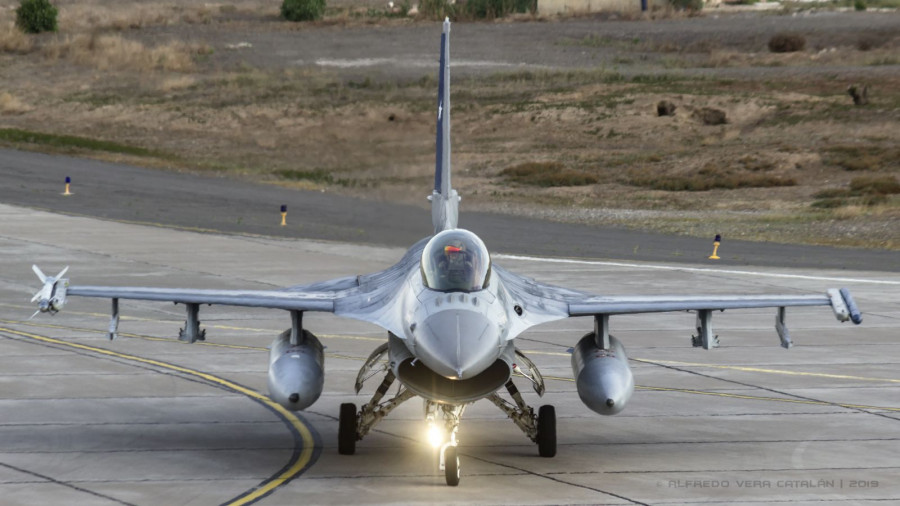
[0, 0, 900, 249]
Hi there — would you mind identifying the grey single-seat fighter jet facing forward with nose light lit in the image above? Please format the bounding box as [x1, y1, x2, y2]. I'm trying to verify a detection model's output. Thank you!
[33, 20, 862, 486]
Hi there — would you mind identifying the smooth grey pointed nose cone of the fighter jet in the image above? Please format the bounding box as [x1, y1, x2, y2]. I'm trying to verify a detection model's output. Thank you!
[416, 309, 500, 379]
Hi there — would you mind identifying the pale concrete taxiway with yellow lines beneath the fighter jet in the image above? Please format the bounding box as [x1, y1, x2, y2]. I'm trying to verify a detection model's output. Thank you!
[0, 205, 900, 504]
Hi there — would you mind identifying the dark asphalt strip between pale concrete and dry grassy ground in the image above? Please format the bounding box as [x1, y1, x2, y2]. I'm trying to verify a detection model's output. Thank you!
[0, 149, 900, 272]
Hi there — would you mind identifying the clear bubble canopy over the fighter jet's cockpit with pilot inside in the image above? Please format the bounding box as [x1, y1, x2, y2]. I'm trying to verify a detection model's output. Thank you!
[422, 229, 491, 292]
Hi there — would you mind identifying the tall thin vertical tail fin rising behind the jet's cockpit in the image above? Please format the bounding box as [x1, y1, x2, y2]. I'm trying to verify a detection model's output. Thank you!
[429, 18, 459, 234]
